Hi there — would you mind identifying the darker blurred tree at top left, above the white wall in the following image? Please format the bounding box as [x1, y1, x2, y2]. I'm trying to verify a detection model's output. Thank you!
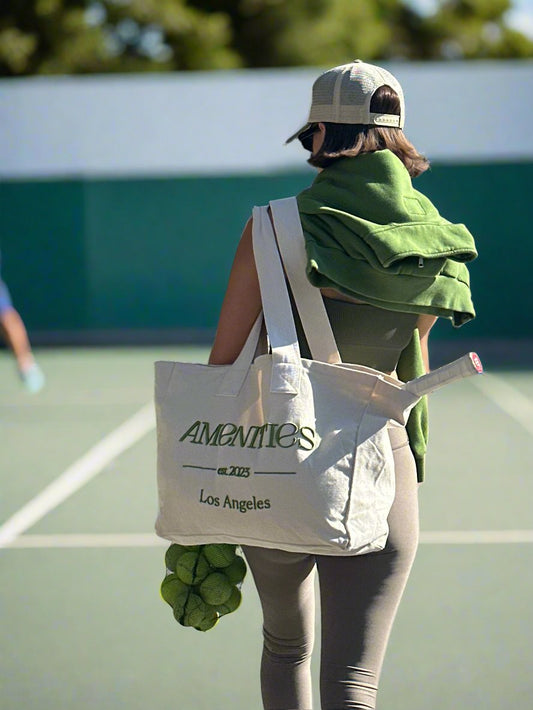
[0, 0, 242, 76]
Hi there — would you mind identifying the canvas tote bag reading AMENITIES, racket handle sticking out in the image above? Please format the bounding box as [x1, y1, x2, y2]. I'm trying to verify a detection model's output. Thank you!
[155, 198, 478, 555]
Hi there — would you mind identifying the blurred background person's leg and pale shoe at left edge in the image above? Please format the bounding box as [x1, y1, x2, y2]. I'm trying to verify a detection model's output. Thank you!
[0, 250, 45, 394]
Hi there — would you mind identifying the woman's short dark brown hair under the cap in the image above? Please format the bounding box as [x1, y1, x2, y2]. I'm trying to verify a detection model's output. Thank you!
[307, 86, 429, 177]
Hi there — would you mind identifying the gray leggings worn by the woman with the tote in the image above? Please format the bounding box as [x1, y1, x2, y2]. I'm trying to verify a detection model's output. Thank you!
[243, 428, 418, 710]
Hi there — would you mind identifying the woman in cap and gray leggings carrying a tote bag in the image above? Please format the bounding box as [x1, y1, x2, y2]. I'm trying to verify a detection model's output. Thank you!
[209, 60, 476, 710]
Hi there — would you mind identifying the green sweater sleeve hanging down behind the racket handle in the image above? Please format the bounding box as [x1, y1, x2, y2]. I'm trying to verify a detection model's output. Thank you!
[396, 328, 429, 483]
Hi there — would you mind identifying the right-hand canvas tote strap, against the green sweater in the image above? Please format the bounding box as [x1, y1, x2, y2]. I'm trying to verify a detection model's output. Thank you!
[270, 197, 341, 363]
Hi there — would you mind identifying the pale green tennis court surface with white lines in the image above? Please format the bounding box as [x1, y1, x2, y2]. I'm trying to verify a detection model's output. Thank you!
[0, 347, 533, 710]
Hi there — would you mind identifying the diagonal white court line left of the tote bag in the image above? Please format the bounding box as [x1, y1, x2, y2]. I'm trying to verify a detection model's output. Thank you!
[0, 402, 155, 548]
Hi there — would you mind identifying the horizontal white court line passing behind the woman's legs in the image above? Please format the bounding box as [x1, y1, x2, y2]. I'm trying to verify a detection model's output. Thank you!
[6, 530, 533, 549]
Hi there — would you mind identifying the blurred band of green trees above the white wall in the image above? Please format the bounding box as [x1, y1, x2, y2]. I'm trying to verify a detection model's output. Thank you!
[0, 0, 533, 76]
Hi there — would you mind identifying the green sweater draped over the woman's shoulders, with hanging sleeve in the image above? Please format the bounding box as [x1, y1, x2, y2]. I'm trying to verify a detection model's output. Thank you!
[297, 150, 477, 480]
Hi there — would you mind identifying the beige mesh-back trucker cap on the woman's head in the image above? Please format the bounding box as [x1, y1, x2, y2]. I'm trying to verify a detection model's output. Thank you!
[286, 59, 405, 143]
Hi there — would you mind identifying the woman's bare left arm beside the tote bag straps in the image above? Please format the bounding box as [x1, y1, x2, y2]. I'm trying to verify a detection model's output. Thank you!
[209, 218, 261, 365]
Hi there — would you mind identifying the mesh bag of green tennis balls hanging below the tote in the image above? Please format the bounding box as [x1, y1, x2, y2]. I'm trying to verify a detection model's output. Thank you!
[160, 543, 246, 631]
